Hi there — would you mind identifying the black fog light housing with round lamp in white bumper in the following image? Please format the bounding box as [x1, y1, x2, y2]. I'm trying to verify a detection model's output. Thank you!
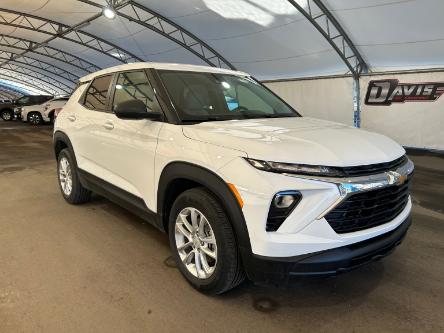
[265, 191, 302, 231]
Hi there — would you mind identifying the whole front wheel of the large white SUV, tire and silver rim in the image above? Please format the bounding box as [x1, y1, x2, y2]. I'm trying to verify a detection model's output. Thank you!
[168, 188, 245, 295]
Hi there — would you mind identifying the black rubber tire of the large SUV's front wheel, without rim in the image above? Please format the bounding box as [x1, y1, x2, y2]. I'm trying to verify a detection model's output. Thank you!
[168, 187, 245, 295]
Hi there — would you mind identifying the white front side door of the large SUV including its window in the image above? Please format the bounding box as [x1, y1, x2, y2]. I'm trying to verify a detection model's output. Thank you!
[95, 70, 163, 210]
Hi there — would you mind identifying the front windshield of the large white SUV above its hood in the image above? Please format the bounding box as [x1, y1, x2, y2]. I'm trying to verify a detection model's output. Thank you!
[159, 71, 299, 122]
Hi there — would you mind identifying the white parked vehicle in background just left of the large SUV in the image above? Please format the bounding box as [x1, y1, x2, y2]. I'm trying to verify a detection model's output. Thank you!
[21, 96, 69, 125]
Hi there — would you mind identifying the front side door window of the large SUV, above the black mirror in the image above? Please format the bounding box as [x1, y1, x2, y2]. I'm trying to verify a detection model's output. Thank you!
[113, 71, 154, 112]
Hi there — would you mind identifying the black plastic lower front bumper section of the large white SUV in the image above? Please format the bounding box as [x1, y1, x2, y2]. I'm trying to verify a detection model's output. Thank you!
[243, 216, 411, 285]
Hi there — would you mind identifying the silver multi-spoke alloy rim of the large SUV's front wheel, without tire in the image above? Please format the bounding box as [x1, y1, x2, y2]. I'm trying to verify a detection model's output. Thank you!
[175, 207, 217, 279]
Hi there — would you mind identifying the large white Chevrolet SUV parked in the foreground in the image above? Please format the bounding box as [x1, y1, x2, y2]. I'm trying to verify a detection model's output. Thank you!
[54, 63, 413, 294]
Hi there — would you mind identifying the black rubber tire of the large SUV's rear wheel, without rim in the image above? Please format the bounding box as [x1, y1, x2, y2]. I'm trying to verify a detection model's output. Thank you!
[57, 148, 91, 205]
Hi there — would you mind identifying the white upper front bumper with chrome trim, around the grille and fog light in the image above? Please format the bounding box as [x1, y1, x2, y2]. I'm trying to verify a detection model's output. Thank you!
[218, 158, 414, 258]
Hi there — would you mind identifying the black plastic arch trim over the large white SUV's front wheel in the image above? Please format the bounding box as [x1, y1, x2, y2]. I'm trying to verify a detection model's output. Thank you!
[157, 162, 251, 252]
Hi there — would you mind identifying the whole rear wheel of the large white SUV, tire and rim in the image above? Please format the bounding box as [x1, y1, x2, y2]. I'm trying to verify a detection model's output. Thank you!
[57, 148, 91, 204]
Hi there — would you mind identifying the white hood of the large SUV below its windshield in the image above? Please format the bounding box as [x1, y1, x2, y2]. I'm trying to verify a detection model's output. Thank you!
[183, 117, 405, 166]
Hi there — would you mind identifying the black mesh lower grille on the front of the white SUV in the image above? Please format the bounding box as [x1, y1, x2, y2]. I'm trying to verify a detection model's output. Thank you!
[325, 177, 411, 234]
